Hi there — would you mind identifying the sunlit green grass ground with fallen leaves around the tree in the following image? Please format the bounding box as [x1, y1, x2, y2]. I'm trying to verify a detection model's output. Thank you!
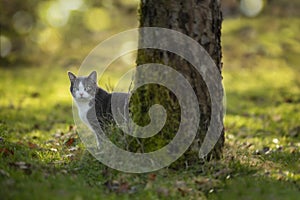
[0, 17, 300, 200]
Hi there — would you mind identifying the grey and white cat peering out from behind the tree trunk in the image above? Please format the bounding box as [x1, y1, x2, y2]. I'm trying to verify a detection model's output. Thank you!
[68, 71, 129, 145]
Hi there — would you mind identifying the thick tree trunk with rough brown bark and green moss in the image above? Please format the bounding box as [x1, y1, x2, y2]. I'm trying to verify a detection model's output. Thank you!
[131, 0, 224, 164]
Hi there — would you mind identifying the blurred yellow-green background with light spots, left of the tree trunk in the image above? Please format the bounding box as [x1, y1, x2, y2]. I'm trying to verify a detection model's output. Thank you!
[0, 0, 138, 67]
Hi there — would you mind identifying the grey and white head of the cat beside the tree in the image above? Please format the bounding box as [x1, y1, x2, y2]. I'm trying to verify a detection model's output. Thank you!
[68, 71, 98, 101]
